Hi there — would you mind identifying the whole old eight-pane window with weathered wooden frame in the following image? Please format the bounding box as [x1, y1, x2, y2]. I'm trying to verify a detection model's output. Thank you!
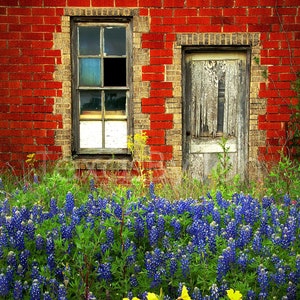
[72, 19, 130, 154]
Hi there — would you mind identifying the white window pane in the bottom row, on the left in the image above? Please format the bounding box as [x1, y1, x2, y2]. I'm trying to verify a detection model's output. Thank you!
[80, 121, 102, 148]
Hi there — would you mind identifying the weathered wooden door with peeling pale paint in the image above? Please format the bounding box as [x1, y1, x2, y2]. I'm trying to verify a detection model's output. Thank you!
[183, 51, 249, 181]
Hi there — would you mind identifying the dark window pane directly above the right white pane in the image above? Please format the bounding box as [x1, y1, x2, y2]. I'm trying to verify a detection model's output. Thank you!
[105, 91, 126, 115]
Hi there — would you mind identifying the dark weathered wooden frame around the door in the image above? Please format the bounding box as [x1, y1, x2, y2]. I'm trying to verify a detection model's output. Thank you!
[181, 45, 251, 181]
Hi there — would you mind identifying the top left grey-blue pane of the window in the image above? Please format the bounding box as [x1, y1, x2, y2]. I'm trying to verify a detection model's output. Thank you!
[79, 27, 100, 55]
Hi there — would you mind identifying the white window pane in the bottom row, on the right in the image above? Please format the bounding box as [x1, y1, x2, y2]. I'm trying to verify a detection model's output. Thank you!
[105, 121, 127, 148]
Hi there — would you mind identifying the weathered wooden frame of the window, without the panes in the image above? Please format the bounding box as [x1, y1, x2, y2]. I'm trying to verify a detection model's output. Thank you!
[71, 17, 133, 158]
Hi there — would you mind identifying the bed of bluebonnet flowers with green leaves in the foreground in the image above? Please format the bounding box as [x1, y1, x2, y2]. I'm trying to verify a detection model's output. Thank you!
[0, 185, 300, 300]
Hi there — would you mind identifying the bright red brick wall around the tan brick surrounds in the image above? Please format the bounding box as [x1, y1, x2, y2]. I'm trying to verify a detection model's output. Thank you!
[0, 0, 300, 173]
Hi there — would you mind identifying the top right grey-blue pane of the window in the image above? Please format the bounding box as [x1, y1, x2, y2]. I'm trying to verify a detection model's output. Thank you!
[104, 27, 126, 56]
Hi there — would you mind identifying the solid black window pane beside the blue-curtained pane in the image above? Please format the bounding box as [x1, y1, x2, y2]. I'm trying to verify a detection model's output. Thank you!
[104, 58, 126, 86]
